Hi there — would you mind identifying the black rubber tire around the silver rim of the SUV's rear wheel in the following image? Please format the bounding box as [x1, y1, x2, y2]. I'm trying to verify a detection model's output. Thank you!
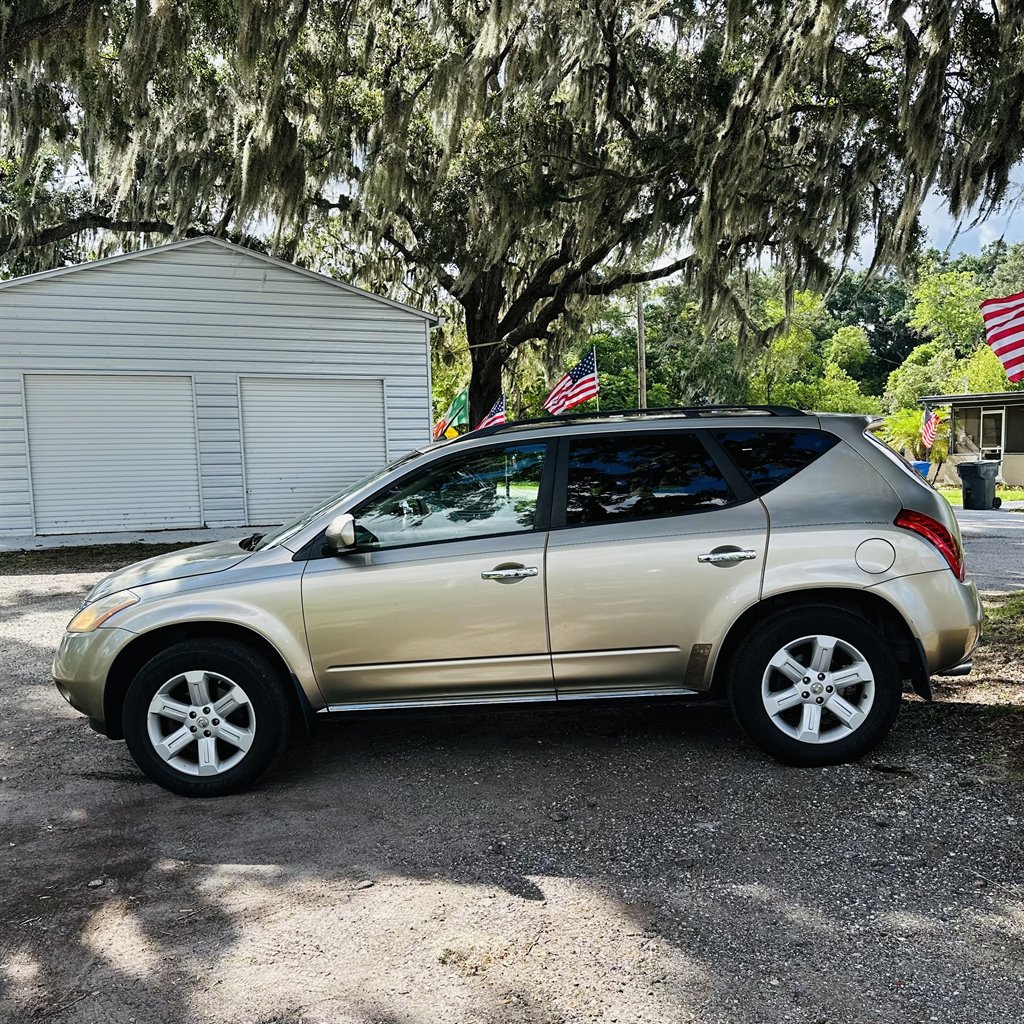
[729, 606, 902, 767]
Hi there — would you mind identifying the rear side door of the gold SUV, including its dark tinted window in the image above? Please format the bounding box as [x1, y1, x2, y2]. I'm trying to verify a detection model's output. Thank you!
[547, 431, 768, 699]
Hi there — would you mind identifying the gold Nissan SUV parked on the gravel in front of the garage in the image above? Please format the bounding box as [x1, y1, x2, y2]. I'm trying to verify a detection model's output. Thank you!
[53, 407, 981, 796]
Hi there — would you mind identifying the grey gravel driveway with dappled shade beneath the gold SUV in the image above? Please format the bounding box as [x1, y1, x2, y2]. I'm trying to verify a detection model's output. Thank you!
[0, 573, 1024, 1024]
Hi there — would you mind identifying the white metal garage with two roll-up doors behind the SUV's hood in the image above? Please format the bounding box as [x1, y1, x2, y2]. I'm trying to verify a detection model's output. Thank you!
[0, 238, 437, 538]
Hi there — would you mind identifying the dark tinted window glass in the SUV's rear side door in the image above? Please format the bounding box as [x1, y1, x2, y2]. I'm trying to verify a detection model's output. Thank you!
[565, 434, 735, 525]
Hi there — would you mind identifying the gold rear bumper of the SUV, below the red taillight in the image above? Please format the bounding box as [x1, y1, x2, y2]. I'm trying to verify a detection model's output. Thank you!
[869, 569, 984, 676]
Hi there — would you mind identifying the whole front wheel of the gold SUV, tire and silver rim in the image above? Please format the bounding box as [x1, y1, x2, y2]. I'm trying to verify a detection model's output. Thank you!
[123, 639, 289, 797]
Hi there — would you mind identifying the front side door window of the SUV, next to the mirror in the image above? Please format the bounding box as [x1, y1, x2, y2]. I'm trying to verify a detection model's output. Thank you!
[353, 444, 547, 549]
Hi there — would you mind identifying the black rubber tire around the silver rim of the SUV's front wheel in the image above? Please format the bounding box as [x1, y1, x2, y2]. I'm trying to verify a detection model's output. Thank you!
[123, 638, 290, 797]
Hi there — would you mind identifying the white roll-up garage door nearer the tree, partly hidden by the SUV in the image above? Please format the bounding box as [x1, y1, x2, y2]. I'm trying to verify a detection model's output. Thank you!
[241, 377, 387, 525]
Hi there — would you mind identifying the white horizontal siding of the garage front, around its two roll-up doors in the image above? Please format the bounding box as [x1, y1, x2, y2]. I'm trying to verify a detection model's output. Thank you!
[0, 240, 430, 535]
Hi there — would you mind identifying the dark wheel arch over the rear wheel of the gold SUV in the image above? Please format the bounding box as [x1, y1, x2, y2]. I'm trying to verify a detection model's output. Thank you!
[709, 587, 932, 700]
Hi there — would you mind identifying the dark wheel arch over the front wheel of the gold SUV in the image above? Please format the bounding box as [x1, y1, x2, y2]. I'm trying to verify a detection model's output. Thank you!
[103, 622, 314, 739]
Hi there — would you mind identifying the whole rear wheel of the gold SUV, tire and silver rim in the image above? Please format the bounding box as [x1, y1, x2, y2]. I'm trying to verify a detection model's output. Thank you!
[729, 608, 901, 765]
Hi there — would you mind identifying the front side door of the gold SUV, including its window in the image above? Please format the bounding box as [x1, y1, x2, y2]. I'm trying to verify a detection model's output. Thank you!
[302, 441, 554, 707]
